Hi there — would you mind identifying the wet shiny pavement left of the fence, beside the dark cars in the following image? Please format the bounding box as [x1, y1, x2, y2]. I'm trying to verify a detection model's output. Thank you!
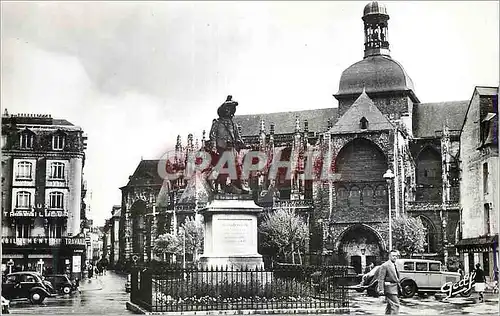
[10, 271, 132, 315]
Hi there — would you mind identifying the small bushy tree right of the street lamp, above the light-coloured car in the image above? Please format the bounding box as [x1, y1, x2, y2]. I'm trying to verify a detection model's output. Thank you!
[392, 215, 426, 257]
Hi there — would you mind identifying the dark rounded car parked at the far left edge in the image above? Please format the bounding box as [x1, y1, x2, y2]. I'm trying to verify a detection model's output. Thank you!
[2, 271, 53, 304]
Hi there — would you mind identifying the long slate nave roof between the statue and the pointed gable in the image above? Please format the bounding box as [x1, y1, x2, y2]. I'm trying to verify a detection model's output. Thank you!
[233, 108, 337, 136]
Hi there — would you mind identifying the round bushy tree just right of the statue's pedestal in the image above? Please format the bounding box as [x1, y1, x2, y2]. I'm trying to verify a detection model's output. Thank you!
[259, 209, 309, 264]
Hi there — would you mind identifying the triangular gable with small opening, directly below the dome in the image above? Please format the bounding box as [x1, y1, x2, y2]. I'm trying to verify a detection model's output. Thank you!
[330, 90, 394, 134]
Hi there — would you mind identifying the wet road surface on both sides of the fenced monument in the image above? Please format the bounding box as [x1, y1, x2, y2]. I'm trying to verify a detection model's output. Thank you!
[5, 271, 498, 316]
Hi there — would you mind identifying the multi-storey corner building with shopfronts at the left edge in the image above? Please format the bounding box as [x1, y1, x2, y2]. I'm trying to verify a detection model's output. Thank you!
[2, 110, 86, 277]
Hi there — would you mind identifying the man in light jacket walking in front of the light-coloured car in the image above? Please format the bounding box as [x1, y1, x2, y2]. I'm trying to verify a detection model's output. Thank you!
[377, 250, 399, 315]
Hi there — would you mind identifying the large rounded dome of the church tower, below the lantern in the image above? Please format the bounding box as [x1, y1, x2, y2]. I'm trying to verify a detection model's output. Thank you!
[337, 55, 414, 95]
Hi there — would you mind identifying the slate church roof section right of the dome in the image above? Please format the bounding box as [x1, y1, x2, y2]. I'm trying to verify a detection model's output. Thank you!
[413, 100, 470, 137]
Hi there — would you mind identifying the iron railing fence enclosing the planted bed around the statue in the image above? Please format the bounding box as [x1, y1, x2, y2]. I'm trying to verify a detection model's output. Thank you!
[131, 266, 349, 312]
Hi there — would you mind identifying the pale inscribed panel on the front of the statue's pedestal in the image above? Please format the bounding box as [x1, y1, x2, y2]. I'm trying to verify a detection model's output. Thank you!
[215, 219, 252, 254]
